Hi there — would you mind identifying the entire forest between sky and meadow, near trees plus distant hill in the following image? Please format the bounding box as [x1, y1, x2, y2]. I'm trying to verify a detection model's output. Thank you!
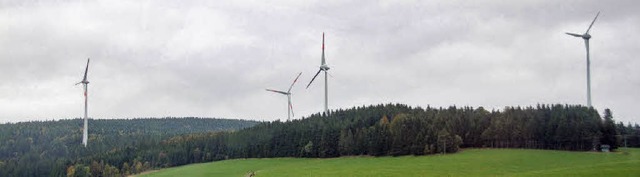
[0, 104, 640, 176]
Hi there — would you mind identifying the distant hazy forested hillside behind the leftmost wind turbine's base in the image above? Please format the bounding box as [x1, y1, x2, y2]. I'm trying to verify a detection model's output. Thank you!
[0, 118, 258, 176]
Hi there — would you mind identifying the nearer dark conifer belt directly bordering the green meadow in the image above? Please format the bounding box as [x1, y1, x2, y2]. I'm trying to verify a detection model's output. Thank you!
[0, 104, 640, 176]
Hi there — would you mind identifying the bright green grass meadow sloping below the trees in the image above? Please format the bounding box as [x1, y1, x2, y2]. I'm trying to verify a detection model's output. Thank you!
[143, 148, 640, 177]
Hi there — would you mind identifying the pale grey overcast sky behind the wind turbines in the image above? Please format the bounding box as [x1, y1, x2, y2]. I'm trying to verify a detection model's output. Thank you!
[0, 0, 640, 123]
